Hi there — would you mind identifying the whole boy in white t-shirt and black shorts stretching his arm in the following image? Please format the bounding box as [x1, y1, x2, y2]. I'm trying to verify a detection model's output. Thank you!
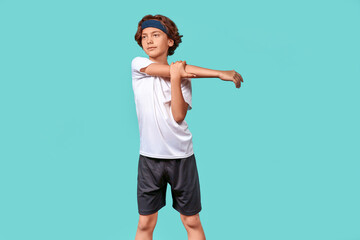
[131, 15, 243, 240]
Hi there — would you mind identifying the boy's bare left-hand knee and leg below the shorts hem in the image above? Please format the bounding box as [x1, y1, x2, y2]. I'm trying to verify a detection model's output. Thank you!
[135, 212, 158, 240]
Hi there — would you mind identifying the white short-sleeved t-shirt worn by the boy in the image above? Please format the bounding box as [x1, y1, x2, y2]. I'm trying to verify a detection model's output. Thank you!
[131, 57, 194, 159]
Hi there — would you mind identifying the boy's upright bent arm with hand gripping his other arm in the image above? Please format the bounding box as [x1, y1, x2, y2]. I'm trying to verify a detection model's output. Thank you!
[170, 61, 189, 123]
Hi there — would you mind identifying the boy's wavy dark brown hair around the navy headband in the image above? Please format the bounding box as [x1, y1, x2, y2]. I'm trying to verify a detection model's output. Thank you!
[135, 14, 183, 56]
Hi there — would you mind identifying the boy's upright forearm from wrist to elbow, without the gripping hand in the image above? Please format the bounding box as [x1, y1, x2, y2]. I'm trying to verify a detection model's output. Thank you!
[170, 75, 188, 122]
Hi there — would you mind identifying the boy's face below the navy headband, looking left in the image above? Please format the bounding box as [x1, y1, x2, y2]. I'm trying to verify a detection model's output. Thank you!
[141, 27, 174, 58]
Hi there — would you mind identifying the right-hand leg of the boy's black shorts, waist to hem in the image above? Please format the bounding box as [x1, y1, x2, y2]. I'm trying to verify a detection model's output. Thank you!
[167, 154, 201, 216]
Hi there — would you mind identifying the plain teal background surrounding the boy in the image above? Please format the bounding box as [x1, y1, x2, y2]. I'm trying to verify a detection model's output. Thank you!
[0, 0, 360, 240]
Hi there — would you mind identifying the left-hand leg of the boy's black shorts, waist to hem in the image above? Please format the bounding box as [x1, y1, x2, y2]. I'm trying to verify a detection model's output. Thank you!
[137, 155, 167, 215]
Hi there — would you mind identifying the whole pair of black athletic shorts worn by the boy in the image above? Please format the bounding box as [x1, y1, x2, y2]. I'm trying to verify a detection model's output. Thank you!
[137, 154, 201, 216]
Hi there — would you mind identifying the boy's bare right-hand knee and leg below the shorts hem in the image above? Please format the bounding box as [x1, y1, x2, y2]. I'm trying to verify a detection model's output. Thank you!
[180, 213, 206, 240]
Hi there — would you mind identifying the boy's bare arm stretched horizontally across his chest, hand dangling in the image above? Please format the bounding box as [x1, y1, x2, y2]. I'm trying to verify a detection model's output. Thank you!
[140, 61, 244, 88]
